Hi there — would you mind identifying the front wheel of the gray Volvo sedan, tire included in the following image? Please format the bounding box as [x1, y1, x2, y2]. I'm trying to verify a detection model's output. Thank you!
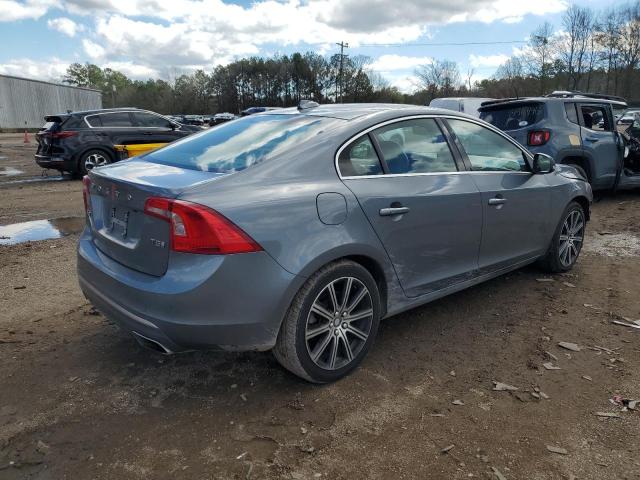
[540, 202, 587, 273]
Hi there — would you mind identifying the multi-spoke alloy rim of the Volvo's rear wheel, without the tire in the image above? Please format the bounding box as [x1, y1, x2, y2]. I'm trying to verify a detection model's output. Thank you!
[305, 277, 373, 370]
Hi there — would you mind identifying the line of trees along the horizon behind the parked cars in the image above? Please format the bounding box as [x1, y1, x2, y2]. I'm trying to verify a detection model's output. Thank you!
[63, 0, 640, 114]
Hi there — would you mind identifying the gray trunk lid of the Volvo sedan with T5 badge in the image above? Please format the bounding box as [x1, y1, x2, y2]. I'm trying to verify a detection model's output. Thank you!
[85, 160, 223, 276]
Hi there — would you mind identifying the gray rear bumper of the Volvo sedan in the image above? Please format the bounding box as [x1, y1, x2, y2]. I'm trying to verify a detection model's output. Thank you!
[78, 231, 304, 352]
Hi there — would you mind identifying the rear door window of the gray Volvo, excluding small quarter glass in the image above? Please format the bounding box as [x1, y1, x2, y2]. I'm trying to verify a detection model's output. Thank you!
[373, 118, 458, 174]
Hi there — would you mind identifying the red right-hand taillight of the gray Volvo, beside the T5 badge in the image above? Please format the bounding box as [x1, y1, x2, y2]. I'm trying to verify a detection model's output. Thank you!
[144, 197, 262, 255]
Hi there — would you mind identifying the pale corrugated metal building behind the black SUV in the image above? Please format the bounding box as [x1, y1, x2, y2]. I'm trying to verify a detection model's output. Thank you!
[0, 75, 102, 131]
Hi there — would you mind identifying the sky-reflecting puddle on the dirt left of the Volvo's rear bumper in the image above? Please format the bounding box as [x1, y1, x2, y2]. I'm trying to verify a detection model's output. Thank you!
[0, 217, 85, 245]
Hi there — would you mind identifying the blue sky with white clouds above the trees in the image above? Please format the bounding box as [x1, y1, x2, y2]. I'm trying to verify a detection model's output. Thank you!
[0, 0, 621, 91]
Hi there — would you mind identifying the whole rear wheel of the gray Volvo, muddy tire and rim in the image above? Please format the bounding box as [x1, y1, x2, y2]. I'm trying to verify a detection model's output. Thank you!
[273, 260, 380, 383]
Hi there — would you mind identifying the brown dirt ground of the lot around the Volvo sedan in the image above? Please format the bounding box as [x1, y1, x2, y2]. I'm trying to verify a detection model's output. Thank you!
[0, 136, 640, 480]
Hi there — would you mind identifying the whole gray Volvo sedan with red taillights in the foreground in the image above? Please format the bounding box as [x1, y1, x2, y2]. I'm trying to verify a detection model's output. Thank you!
[78, 102, 592, 383]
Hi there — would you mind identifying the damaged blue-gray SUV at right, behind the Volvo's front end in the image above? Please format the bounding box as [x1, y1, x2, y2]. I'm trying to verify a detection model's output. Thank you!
[480, 92, 640, 190]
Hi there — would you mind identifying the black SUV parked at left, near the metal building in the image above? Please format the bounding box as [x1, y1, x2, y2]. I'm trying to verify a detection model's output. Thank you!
[35, 108, 202, 175]
